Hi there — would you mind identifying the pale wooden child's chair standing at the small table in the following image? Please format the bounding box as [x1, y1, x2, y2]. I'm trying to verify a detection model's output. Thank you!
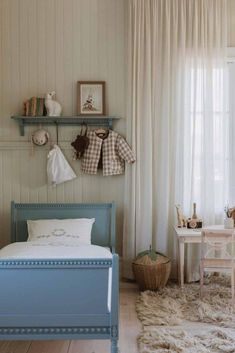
[200, 229, 235, 306]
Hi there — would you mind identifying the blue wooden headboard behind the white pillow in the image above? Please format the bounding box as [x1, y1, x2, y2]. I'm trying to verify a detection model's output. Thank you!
[11, 201, 116, 251]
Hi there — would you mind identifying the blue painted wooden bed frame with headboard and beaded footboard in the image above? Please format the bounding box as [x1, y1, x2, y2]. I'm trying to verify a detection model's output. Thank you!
[0, 202, 119, 353]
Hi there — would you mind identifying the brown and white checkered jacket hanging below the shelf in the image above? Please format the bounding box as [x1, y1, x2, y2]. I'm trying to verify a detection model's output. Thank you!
[82, 130, 135, 176]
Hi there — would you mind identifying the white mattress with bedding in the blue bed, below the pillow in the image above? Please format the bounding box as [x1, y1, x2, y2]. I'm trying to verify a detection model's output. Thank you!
[0, 241, 112, 312]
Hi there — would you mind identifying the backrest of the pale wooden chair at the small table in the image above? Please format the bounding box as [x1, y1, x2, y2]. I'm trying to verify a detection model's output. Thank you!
[201, 229, 235, 260]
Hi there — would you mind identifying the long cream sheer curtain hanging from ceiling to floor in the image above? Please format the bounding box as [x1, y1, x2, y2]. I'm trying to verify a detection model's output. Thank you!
[123, 0, 227, 279]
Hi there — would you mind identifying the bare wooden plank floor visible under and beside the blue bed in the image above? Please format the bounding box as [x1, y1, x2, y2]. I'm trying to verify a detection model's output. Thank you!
[0, 284, 141, 353]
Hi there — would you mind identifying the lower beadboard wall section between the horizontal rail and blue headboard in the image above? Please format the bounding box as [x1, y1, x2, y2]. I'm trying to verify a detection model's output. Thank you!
[0, 145, 123, 251]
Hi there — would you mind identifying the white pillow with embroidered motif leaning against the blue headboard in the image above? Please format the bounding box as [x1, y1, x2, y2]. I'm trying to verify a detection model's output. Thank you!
[27, 218, 95, 245]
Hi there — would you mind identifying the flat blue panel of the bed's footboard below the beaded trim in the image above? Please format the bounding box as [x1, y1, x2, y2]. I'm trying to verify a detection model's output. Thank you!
[0, 265, 109, 327]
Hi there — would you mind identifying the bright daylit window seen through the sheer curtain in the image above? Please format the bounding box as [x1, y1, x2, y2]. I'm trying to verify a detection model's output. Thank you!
[184, 58, 231, 223]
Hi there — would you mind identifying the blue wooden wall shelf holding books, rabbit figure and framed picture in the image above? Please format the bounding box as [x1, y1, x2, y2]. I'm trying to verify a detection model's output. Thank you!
[11, 115, 120, 136]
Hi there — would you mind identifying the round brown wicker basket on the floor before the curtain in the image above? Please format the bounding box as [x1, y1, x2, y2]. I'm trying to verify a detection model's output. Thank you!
[132, 252, 171, 290]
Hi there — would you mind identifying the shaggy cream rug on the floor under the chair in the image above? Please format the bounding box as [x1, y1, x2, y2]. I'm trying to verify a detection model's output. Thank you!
[136, 276, 235, 353]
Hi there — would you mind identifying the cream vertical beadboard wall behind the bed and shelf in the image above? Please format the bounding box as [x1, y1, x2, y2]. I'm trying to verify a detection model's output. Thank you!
[0, 0, 126, 252]
